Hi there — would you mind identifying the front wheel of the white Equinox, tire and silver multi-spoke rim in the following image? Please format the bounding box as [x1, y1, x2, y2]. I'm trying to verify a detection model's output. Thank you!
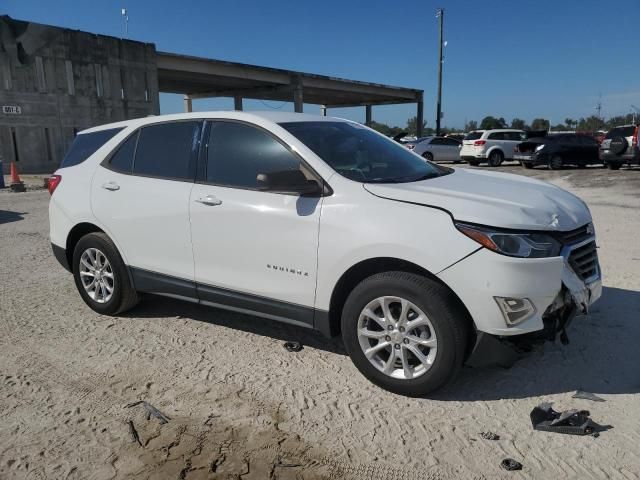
[342, 272, 469, 397]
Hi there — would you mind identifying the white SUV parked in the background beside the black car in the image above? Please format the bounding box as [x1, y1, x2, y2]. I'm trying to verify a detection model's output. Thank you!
[460, 128, 526, 167]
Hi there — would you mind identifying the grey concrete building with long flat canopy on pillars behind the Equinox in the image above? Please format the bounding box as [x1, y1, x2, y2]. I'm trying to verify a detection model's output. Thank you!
[0, 16, 423, 173]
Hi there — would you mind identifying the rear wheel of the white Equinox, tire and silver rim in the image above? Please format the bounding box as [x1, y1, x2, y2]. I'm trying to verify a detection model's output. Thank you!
[72, 232, 139, 315]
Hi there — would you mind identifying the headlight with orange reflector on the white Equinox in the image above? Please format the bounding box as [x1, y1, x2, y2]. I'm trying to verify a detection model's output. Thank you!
[456, 223, 562, 258]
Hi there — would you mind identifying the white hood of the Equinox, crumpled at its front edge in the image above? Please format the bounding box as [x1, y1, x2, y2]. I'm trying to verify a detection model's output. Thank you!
[364, 168, 591, 231]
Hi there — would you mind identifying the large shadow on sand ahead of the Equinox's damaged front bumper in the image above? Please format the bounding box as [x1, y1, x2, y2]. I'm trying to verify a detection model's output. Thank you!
[430, 287, 640, 401]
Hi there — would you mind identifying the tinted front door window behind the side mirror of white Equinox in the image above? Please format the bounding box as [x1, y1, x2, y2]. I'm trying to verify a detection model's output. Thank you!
[205, 121, 301, 190]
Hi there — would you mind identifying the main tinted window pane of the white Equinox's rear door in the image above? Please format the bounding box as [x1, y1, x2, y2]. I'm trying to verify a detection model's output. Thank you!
[133, 122, 202, 180]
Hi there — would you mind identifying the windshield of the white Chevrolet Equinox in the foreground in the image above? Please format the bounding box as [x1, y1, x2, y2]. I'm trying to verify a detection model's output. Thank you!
[280, 121, 452, 183]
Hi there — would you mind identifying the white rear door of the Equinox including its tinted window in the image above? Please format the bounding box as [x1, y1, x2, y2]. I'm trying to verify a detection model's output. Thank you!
[91, 121, 202, 283]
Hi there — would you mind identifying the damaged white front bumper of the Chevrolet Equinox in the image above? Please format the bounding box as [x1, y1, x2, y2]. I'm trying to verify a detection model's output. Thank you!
[438, 249, 602, 336]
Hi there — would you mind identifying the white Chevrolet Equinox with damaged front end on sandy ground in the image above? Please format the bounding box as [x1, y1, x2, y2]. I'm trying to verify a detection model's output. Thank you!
[49, 112, 601, 395]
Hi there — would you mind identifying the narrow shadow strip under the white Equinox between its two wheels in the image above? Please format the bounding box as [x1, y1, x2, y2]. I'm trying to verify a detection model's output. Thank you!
[127, 294, 347, 355]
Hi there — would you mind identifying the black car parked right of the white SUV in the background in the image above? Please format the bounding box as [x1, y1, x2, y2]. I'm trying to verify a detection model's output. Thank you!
[513, 133, 601, 170]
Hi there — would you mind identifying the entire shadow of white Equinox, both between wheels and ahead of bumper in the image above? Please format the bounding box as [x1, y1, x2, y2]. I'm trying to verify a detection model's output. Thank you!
[124, 287, 640, 401]
